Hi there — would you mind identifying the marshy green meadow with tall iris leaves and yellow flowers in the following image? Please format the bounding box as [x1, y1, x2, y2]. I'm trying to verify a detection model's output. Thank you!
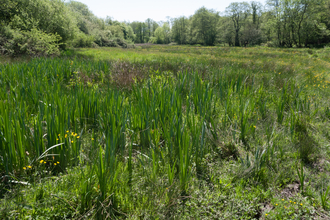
[0, 46, 330, 219]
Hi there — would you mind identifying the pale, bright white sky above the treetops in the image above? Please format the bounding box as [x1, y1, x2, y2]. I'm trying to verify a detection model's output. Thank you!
[70, 0, 266, 22]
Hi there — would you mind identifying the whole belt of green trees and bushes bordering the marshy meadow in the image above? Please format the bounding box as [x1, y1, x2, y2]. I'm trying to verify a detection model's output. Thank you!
[0, 0, 330, 55]
